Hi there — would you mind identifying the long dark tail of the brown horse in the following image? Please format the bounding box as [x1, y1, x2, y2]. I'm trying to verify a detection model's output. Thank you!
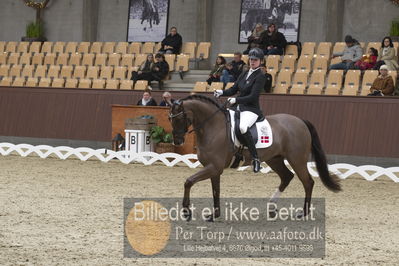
[303, 120, 342, 192]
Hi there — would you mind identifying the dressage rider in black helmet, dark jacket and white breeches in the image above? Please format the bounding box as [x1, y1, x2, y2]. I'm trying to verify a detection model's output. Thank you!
[214, 48, 266, 173]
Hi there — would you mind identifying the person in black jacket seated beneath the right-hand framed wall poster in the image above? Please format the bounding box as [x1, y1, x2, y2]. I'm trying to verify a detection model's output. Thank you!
[261, 23, 287, 55]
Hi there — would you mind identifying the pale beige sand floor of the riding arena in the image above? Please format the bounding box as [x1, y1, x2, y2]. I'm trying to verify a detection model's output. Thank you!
[0, 156, 399, 265]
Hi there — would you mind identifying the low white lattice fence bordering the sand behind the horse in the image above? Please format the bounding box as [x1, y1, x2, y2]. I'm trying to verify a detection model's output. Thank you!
[0, 143, 399, 183]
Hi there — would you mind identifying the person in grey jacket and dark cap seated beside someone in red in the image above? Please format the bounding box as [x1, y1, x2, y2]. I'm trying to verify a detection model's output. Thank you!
[330, 35, 363, 71]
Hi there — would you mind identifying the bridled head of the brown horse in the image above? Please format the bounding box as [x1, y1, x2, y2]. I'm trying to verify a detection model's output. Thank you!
[169, 101, 191, 146]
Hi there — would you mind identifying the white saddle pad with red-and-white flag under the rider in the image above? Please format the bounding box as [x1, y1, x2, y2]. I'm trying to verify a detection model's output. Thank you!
[229, 110, 273, 149]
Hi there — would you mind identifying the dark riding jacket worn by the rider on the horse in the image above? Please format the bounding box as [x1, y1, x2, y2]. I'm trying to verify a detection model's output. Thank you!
[223, 68, 266, 116]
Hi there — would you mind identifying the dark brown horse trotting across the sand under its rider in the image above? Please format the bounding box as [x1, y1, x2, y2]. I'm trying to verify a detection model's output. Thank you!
[169, 94, 341, 221]
